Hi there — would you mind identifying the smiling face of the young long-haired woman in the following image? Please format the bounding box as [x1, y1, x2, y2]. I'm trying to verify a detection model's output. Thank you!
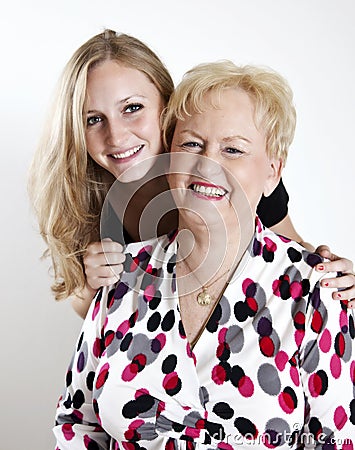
[85, 60, 163, 182]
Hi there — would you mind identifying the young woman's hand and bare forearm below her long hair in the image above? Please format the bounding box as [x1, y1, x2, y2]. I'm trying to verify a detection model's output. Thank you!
[71, 239, 125, 319]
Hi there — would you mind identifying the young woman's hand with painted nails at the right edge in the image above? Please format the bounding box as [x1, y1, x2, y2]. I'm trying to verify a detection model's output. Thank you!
[315, 245, 355, 308]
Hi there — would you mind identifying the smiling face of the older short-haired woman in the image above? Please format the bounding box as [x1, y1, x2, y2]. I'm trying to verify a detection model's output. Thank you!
[169, 88, 281, 230]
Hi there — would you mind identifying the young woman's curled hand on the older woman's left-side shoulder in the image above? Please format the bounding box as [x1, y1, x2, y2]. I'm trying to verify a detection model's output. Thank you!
[83, 238, 125, 289]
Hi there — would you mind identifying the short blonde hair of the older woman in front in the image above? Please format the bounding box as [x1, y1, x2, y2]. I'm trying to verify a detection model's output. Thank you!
[163, 61, 296, 163]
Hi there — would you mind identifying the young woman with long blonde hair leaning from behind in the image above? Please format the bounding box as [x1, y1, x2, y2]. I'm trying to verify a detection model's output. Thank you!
[29, 30, 355, 317]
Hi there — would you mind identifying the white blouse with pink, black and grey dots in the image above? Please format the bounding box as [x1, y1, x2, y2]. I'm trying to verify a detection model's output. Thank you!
[54, 222, 355, 450]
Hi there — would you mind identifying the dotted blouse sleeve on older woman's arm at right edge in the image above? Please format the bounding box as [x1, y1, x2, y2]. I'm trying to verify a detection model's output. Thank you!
[299, 283, 355, 449]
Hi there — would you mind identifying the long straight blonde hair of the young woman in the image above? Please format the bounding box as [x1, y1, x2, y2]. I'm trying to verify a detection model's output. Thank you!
[28, 30, 174, 300]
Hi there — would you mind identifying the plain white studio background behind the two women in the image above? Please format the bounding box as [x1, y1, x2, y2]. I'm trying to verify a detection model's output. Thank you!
[0, 0, 355, 450]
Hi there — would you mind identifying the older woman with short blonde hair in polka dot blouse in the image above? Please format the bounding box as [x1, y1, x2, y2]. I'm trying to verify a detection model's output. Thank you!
[54, 62, 355, 450]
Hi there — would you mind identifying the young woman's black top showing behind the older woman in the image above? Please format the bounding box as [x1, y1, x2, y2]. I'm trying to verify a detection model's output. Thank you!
[101, 180, 289, 245]
